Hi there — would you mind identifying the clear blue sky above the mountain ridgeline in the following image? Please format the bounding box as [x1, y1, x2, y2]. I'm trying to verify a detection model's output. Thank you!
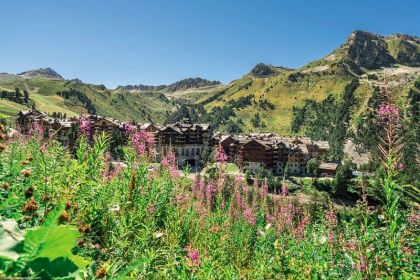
[0, 0, 420, 87]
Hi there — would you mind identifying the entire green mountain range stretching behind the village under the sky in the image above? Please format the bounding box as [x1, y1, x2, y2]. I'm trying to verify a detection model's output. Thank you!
[0, 31, 420, 134]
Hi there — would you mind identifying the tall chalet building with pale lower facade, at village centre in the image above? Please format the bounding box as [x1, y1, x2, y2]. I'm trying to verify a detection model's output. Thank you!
[156, 118, 213, 170]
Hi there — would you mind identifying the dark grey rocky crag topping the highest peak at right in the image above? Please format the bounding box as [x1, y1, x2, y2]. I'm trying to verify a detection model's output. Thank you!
[343, 31, 395, 69]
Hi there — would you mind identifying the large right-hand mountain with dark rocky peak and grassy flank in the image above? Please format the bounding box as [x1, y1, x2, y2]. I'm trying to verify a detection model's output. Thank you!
[187, 31, 420, 134]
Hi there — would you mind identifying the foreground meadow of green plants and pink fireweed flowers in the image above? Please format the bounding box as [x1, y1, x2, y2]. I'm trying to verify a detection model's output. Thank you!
[0, 94, 419, 279]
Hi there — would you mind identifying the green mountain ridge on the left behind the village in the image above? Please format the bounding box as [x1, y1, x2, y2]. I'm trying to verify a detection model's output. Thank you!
[0, 69, 176, 123]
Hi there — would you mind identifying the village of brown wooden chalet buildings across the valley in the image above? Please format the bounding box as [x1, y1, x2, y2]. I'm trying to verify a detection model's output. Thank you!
[16, 110, 340, 177]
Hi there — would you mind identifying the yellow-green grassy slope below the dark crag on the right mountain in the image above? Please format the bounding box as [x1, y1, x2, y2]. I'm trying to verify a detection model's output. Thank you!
[194, 34, 418, 134]
